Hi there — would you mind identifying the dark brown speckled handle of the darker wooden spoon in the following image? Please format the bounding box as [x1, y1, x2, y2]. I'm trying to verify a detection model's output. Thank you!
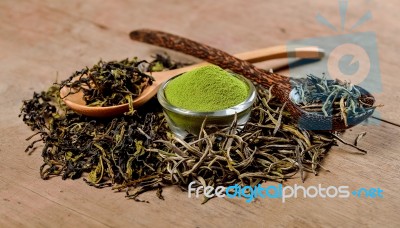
[130, 29, 291, 91]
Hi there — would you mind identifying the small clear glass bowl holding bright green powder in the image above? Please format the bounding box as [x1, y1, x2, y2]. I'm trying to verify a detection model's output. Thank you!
[157, 74, 257, 138]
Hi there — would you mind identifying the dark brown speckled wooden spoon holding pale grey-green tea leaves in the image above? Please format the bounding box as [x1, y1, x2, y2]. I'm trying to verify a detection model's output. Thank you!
[130, 29, 375, 131]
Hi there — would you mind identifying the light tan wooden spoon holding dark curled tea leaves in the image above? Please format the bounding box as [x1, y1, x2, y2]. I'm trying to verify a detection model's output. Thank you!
[60, 45, 324, 117]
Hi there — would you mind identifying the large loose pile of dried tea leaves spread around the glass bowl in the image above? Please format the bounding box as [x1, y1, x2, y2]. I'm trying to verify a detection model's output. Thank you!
[21, 56, 362, 203]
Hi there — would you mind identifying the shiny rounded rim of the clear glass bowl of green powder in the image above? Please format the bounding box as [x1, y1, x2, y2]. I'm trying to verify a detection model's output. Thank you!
[157, 72, 257, 117]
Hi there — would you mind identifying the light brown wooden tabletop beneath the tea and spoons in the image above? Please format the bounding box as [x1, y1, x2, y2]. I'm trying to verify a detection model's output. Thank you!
[0, 0, 400, 227]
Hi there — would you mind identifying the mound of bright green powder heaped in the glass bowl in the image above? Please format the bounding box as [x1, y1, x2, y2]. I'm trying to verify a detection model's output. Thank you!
[165, 65, 249, 112]
